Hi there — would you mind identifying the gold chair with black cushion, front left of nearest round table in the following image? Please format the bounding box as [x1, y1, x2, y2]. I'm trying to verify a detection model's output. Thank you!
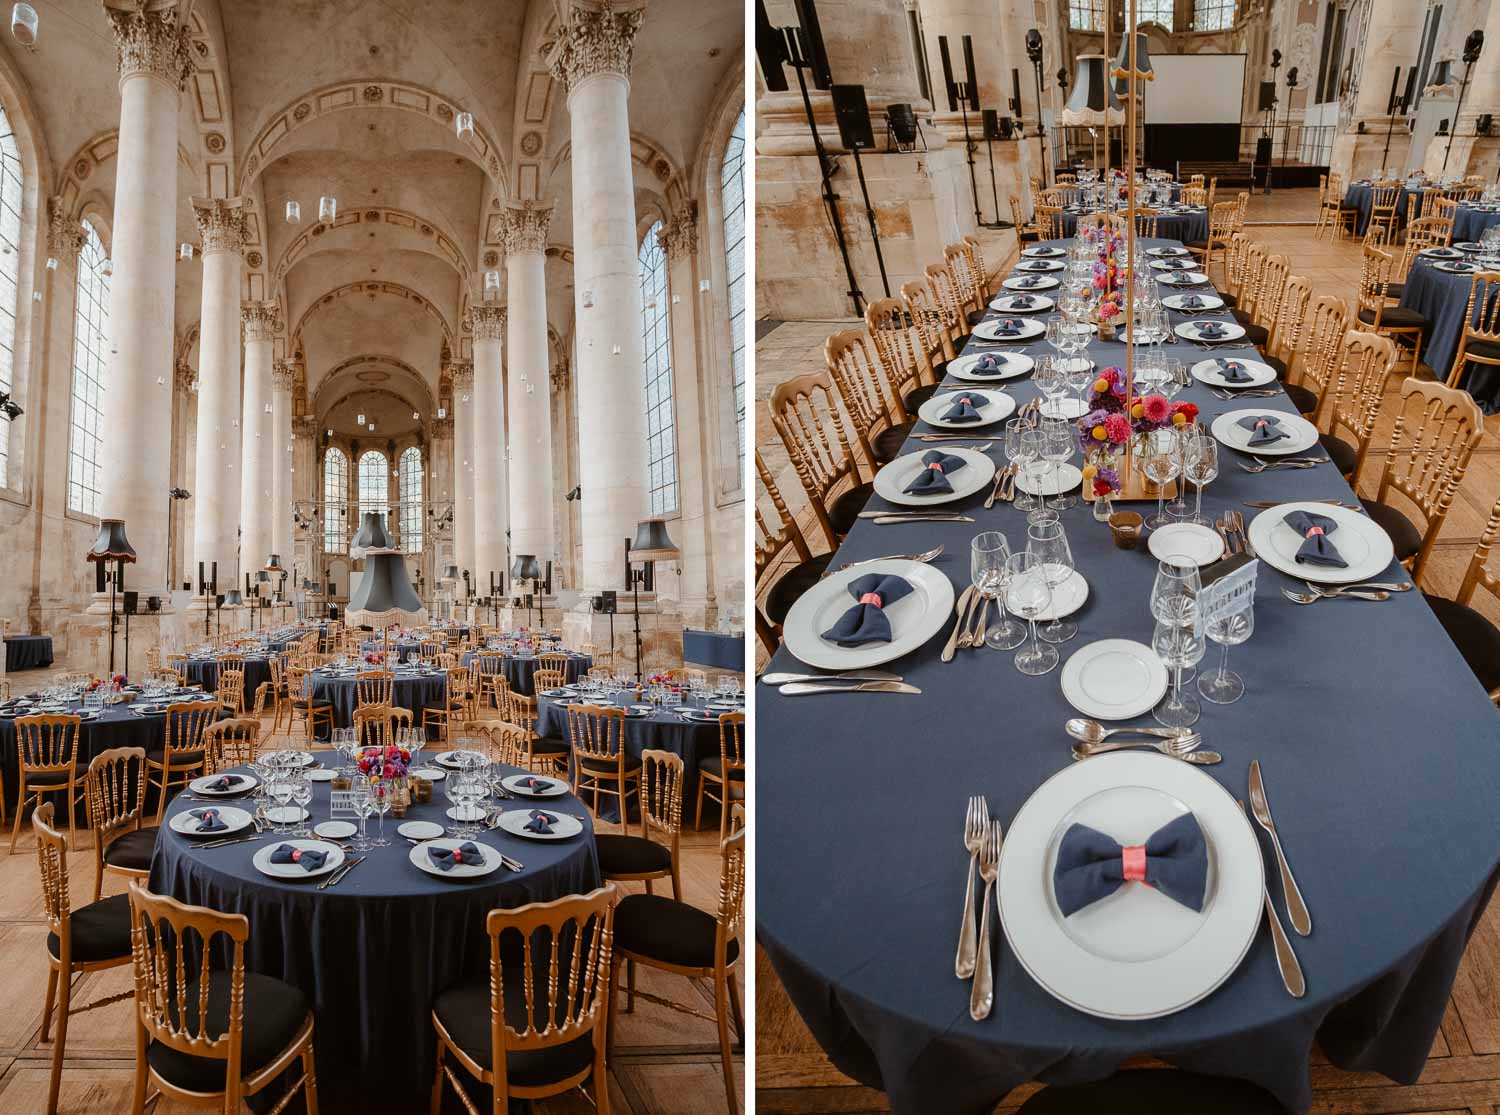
[129, 881, 318, 1115]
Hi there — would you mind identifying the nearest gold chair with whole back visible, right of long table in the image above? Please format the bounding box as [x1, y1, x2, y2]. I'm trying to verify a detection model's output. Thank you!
[1362, 378, 1485, 585]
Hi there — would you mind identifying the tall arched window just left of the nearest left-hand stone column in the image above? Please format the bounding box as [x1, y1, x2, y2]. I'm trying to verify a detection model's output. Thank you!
[68, 221, 110, 515]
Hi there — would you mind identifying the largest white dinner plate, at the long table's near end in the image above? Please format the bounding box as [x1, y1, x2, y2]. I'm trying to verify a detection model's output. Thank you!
[998, 752, 1265, 1022]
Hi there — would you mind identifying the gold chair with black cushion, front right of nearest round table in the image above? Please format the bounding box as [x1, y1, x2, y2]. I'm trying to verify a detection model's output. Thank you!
[432, 885, 618, 1115]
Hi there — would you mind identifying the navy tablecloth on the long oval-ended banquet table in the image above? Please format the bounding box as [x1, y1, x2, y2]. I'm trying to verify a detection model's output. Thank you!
[756, 242, 1500, 1115]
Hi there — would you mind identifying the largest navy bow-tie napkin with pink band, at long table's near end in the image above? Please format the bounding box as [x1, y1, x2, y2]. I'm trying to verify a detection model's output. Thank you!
[1052, 813, 1209, 917]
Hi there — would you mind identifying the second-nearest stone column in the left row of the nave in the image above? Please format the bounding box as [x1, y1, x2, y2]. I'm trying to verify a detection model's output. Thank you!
[191, 198, 245, 606]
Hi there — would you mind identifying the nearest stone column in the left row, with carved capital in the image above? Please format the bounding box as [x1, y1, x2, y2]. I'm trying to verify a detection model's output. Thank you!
[96, 0, 192, 597]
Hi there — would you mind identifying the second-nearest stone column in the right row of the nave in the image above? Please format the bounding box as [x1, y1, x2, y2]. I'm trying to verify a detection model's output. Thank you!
[468, 303, 510, 596]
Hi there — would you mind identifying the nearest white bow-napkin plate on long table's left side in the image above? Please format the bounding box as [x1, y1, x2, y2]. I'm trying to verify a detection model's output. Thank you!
[782, 560, 954, 669]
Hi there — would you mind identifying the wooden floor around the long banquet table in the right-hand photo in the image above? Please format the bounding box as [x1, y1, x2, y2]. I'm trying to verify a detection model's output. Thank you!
[755, 191, 1500, 1115]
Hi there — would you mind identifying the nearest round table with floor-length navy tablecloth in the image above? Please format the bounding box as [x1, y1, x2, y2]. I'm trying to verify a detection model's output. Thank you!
[150, 770, 600, 1115]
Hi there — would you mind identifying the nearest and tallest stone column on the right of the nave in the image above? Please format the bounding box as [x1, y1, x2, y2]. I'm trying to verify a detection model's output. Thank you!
[552, 3, 647, 591]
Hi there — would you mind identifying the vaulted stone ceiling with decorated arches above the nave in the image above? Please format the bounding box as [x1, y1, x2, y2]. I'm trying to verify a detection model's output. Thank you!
[0, 0, 744, 440]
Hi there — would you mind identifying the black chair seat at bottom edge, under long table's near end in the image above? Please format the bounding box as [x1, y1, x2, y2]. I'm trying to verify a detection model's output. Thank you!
[1016, 1068, 1292, 1115]
